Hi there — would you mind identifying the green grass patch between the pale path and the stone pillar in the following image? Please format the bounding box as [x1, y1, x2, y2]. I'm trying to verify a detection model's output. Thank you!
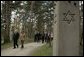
[32, 44, 52, 56]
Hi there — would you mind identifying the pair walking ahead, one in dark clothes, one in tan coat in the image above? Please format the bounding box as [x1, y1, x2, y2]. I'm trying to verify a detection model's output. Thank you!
[12, 29, 25, 49]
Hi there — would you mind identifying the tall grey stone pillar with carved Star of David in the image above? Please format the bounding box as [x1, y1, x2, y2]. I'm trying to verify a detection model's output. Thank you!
[53, 1, 79, 56]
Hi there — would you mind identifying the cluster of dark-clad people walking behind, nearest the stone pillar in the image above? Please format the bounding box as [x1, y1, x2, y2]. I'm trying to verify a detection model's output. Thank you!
[34, 32, 53, 43]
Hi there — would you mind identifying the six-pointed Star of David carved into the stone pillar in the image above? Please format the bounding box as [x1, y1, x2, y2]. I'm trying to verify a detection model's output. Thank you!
[62, 10, 75, 24]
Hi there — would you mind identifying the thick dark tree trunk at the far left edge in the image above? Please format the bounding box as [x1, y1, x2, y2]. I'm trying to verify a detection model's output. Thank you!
[2, 1, 11, 43]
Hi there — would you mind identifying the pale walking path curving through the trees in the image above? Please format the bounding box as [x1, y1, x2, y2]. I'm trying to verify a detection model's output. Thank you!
[1, 42, 45, 56]
